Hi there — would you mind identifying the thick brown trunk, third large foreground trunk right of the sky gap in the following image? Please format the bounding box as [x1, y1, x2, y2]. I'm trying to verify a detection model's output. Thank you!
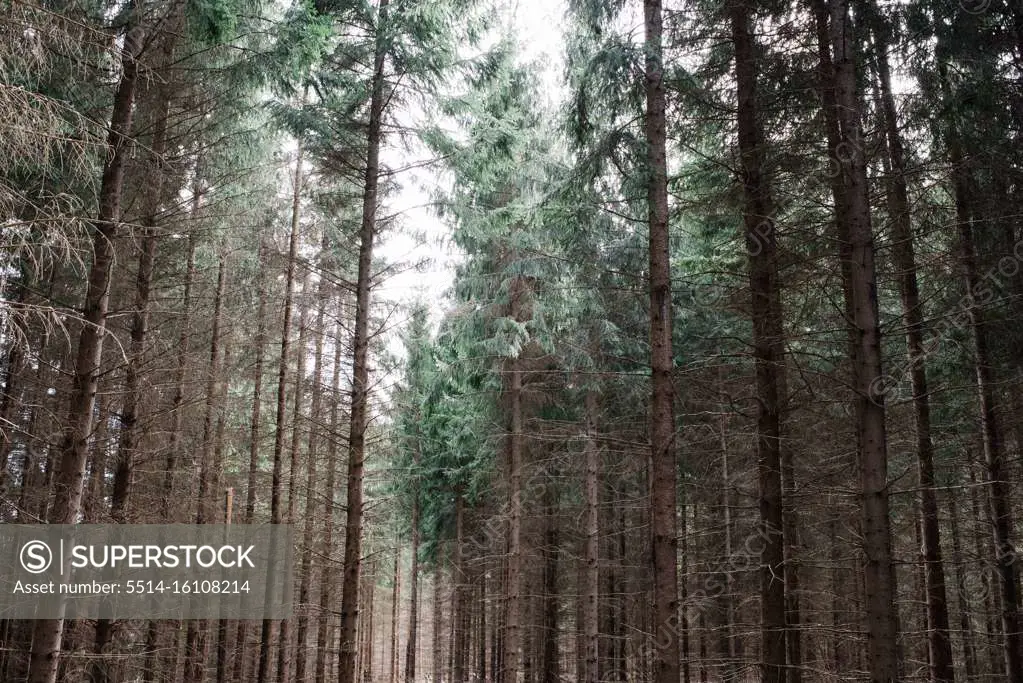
[830, 0, 898, 683]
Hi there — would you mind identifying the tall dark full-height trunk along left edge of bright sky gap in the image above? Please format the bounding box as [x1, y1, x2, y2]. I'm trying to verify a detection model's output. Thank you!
[338, 0, 389, 683]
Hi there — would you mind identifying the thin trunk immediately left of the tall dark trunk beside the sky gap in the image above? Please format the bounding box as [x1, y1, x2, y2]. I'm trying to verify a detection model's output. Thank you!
[316, 322, 345, 683]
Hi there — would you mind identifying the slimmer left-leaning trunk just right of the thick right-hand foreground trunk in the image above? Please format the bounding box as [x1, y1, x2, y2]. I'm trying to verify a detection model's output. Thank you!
[871, 13, 955, 682]
